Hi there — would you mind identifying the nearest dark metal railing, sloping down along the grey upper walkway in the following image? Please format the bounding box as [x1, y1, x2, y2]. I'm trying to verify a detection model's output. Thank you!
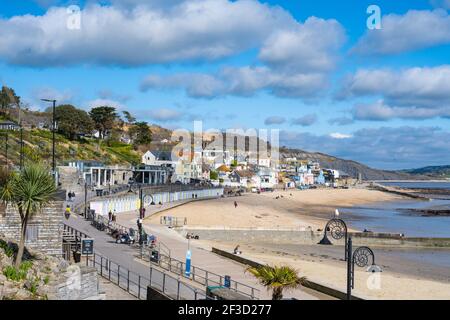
[86, 253, 209, 300]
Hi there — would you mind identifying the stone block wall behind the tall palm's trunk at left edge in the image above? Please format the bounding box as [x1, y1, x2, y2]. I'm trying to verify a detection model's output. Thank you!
[0, 201, 64, 255]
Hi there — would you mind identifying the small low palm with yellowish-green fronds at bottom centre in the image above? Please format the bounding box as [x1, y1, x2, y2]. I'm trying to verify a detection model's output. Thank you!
[246, 265, 307, 300]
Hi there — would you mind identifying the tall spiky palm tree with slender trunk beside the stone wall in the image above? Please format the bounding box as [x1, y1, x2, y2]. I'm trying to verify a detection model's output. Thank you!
[0, 164, 56, 267]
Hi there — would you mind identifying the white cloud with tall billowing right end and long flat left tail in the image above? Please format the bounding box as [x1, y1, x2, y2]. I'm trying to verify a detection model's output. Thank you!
[141, 11, 345, 98]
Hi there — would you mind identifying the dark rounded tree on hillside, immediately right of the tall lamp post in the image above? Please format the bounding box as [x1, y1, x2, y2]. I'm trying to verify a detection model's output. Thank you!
[55, 104, 94, 140]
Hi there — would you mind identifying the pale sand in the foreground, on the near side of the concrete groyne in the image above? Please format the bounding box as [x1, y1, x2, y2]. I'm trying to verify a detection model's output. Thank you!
[201, 241, 450, 300]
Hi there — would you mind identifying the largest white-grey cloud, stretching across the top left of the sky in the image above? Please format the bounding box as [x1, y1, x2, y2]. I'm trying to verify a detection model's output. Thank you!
[0, 0, 295, 66]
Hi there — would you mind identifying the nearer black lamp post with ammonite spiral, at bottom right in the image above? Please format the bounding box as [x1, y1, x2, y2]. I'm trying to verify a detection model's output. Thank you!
[347, 237, 381, 300]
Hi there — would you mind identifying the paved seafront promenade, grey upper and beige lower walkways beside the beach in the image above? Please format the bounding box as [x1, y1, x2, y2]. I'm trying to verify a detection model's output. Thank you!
[66, 195, 333, 300]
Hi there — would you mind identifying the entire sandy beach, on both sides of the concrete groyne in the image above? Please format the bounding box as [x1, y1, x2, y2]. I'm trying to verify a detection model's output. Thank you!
[145, 188, 450, 299]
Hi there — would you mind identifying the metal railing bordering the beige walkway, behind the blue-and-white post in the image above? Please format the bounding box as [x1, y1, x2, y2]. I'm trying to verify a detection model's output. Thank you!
[141, 250, 260, 299]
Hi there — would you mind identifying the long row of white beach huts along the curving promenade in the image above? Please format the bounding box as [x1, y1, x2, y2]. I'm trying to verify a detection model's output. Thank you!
[90, 188, 223, 215]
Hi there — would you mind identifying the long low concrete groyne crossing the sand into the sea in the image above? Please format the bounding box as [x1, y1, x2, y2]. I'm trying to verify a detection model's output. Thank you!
[178, 227, 450, 248]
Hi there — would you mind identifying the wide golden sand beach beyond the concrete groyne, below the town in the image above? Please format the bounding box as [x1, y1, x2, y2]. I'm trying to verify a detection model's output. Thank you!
[147, 188, 402, 230]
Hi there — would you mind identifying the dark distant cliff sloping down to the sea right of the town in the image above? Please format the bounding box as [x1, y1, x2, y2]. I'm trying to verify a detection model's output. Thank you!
[280, 148, 431, 180]
